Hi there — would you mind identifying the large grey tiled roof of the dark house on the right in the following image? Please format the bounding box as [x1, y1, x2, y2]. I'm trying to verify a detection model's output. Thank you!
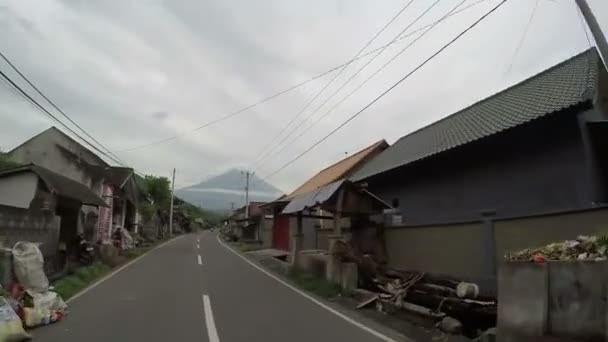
[351, 49, 603, 181]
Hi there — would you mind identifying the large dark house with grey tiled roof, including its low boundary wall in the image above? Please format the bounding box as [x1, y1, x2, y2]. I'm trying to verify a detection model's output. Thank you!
[350, 49, 608, 286]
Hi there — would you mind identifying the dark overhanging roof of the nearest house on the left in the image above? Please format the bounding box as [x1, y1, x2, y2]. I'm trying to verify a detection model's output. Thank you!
[0, 164, 107, 206]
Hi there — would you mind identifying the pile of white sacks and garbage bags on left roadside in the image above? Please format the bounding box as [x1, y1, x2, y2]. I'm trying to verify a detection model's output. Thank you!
[0, 242, 67, 342]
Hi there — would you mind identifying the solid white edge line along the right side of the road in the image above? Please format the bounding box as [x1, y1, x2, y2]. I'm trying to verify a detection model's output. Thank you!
[216, 235, 415, 342]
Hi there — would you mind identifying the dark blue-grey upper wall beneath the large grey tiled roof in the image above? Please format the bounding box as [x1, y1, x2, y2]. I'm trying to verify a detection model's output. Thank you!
[365, 113, 594, 225]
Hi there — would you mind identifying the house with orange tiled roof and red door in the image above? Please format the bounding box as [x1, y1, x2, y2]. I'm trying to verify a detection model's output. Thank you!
[264, 140, 388, 250]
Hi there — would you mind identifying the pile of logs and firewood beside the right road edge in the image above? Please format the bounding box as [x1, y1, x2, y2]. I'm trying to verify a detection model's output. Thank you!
[357, 269, 497, 333]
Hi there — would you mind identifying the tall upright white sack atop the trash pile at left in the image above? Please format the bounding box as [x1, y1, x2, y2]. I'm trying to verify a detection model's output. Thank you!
[13, 242, 49, 292]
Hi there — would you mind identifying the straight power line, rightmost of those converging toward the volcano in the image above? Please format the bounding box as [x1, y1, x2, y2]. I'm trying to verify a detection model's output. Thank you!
[262, 0, 507, 180]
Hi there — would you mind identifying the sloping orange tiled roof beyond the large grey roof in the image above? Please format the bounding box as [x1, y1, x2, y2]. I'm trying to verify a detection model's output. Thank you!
[284, 140, 388, 200]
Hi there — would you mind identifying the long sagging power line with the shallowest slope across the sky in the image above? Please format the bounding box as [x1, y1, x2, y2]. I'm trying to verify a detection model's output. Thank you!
[115, 0, 488, 152]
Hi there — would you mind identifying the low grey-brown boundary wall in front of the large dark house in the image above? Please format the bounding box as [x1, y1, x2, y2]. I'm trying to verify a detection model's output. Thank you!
[385, 208, 608, 294]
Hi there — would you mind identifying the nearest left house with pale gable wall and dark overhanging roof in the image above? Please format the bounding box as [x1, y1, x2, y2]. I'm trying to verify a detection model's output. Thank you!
[0, 164, 106, 272]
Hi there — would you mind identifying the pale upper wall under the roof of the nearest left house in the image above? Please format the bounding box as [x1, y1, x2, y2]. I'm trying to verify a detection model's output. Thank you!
[0, 172, 38, 209]
